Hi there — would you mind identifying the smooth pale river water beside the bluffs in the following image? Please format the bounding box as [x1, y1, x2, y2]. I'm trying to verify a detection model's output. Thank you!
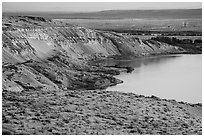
[102, 55, 202, 103]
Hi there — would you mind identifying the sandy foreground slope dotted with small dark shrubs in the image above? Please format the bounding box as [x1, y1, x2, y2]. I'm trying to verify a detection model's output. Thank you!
[2, 90, 202, 135]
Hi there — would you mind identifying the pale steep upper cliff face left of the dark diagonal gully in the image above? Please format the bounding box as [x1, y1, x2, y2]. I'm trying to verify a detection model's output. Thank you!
[3, 26, 120, 62]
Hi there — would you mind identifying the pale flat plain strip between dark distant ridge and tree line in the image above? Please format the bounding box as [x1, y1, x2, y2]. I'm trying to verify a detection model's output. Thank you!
[55, 19, 202, 32]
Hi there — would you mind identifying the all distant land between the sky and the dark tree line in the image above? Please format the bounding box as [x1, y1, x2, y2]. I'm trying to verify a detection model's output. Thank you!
[3, 9, 202, 32]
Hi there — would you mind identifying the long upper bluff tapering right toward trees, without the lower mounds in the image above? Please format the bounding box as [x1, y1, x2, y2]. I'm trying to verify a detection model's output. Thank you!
[2, 16, 182, 62]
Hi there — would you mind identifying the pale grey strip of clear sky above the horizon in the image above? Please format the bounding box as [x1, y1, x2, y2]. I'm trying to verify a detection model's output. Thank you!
[2, 2, 202, 12]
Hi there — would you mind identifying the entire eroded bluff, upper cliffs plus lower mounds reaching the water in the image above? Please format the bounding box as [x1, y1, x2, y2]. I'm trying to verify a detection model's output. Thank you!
[2, 16, 184, 91]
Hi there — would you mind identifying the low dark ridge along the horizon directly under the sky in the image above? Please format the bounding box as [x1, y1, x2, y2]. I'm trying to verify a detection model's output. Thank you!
[3, 8, 202, 19]
